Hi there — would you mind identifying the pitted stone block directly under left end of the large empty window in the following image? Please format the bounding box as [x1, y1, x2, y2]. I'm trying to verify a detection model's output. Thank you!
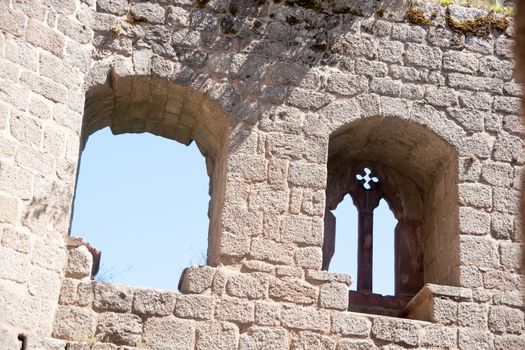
[93, 283, 134, 312]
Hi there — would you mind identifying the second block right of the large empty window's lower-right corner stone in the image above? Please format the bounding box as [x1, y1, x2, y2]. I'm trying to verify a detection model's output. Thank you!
[226, 273, 270, 299]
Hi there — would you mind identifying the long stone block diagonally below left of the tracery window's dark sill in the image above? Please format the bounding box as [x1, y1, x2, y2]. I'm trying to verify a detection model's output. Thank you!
[281, 304, 330, 332]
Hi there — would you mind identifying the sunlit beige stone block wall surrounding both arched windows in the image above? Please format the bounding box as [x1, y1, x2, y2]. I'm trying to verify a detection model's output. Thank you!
[0, 0, 525, 350]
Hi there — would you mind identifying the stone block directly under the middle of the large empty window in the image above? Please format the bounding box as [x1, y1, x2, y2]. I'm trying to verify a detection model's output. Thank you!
[133, 289, 175, 316]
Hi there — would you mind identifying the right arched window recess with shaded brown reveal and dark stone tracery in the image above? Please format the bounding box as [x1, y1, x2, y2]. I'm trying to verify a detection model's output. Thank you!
[323, 118, 459, 316]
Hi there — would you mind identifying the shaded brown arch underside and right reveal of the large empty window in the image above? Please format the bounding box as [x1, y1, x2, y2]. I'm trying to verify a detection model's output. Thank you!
[70, 72, 231, 274]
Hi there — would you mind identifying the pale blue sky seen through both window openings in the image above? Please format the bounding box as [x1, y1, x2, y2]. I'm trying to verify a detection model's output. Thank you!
[71, 128, 396, 294]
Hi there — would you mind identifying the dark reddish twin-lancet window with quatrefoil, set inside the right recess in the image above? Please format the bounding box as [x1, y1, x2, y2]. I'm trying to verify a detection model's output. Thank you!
[323, 162, 423, 315]
